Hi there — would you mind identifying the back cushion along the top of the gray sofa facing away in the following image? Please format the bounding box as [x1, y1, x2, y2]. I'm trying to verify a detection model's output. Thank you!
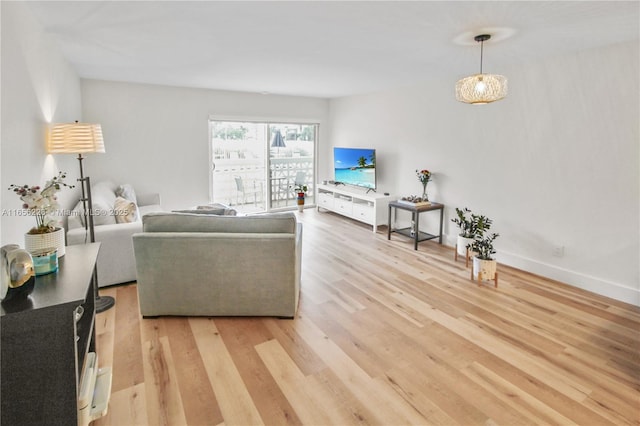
[142, 212, 297, 234]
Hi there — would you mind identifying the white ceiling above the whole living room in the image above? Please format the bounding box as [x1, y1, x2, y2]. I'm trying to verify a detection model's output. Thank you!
[28, 1, 640, 98]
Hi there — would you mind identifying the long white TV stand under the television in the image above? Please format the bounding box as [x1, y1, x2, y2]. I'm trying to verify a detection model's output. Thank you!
[317, 184, 393, 232]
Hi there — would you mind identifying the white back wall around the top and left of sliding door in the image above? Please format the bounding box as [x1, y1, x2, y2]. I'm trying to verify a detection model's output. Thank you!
[82, 80, 328, 209]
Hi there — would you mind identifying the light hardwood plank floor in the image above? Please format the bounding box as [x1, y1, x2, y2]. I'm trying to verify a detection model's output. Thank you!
[94, 210, 640, 426]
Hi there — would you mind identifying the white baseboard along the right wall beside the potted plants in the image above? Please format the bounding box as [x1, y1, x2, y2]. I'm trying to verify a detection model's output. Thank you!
[496, 251, 640, 306]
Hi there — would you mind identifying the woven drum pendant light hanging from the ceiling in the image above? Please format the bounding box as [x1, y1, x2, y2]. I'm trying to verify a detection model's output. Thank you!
[456, 34, 507, 105]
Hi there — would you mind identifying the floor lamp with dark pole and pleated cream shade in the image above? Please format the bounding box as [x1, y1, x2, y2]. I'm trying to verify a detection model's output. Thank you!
[47, 121, 116, 313]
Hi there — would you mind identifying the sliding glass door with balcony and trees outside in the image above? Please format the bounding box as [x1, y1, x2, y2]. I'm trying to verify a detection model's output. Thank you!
[209, 120, 318, 213]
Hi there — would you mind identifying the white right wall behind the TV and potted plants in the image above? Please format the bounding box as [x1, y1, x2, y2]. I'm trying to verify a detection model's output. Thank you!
[328, 42, 640, 305]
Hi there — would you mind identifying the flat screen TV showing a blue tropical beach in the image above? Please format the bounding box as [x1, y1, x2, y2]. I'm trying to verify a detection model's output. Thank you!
[333, 147, 376, 190]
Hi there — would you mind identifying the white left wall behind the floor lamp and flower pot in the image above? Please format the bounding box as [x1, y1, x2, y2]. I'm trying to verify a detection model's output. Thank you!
[0, 2, 81, 247]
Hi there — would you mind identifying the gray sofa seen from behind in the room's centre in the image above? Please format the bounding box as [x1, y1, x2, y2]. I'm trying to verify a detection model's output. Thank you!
[133, 212, 302, 318]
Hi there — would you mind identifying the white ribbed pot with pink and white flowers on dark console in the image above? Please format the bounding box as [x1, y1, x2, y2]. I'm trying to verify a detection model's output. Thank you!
[9, 172, 74, 257]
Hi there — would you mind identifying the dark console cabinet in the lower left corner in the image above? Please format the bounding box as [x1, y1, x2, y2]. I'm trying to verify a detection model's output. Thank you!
[0, 243, 110, 426]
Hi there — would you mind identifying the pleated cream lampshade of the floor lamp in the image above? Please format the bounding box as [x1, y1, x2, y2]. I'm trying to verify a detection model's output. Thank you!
[47, 123, 104, 154]
